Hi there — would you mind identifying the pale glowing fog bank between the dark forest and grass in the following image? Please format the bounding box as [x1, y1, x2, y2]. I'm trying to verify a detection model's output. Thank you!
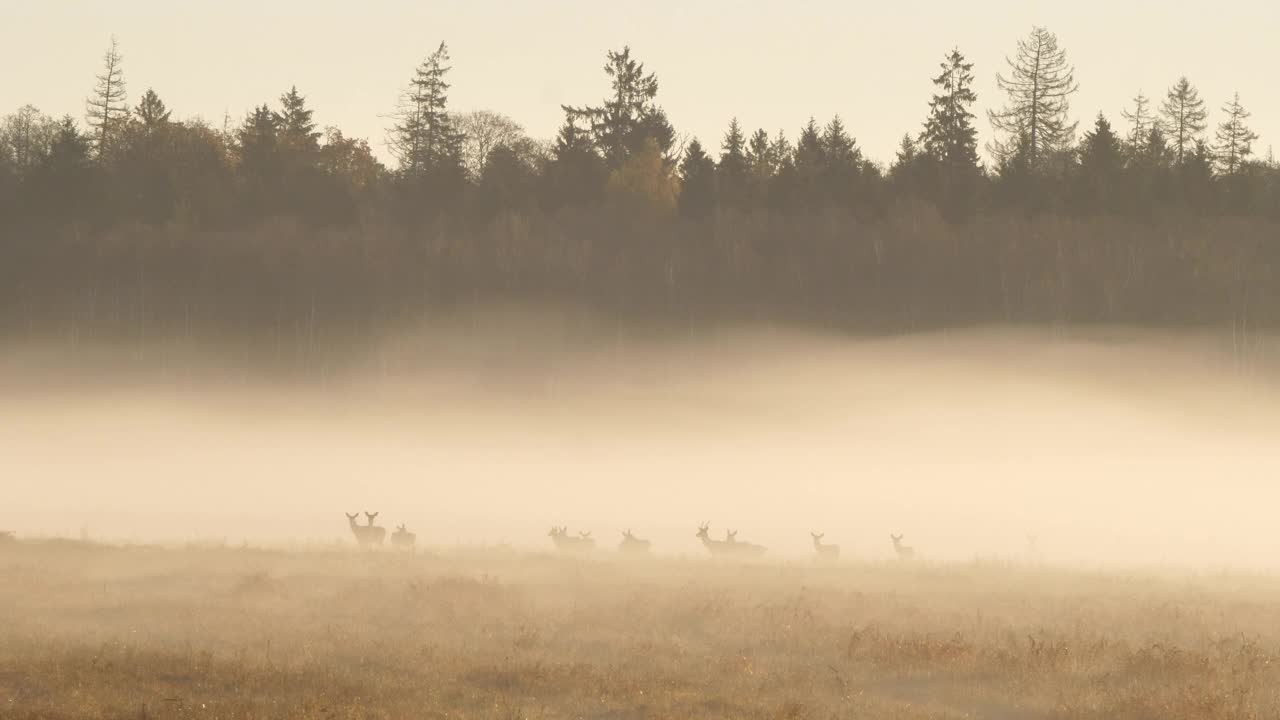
[0, 313, 1280, 569]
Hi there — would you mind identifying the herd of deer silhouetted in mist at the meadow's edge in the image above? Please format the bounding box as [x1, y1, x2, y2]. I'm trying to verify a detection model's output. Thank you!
[346, 512, 915, 562]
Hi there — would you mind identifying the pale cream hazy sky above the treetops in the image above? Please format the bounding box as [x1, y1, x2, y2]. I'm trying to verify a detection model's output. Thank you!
[0, 0, 1280, 160]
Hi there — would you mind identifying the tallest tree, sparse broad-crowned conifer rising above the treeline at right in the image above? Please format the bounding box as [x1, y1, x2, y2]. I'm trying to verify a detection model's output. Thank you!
[988, 27, 1079, 169]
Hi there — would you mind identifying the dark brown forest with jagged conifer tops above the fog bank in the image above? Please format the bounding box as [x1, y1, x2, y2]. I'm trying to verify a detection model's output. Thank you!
[0, 27, 1280, 342]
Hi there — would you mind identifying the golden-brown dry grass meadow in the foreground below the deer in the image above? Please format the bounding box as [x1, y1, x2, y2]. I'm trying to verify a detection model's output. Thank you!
[0, 542, 1280, 720]
